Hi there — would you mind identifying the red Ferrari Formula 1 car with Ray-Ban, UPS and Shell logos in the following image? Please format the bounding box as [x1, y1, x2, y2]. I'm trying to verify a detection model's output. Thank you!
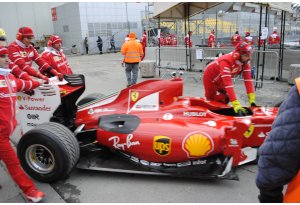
[17, 75, 278, 182]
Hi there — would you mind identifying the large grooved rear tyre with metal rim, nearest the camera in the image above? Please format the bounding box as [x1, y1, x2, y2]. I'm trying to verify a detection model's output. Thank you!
[17, 122, 80, 183]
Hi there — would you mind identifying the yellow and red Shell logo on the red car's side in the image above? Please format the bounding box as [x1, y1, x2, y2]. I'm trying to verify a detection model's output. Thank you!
[182, 132, 214, 158]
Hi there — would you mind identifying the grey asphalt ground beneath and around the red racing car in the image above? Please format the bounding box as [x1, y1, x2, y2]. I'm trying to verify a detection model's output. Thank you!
[0, 53, 291, 203]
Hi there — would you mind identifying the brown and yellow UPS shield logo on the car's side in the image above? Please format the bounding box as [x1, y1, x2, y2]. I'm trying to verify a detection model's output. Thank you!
[153, 136, 172, 156]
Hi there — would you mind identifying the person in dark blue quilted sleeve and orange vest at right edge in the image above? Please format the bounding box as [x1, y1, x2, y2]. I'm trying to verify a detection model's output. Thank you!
[256, 78, 300, 203]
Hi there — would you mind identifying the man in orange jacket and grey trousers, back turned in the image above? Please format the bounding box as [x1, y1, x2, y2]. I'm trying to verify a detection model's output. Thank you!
[121, 32, 144, 87]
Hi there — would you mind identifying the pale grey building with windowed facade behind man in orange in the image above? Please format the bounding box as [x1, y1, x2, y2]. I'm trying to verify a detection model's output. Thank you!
[53, 2, 147, 53]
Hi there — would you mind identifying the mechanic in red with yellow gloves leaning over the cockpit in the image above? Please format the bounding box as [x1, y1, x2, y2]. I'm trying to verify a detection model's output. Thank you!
[203, 42, 256, 114]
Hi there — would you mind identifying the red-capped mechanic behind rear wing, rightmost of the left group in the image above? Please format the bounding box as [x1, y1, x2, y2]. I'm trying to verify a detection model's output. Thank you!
[42, 35, 73, 74]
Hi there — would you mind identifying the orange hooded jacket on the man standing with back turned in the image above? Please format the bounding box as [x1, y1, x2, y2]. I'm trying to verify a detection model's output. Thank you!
[121, 38, 144, 63]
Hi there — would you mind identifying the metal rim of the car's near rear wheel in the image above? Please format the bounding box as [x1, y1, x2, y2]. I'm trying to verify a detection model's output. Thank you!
[25, 144, 55, 174]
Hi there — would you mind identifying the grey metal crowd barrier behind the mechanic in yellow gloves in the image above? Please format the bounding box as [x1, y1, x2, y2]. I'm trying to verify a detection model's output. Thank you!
[156, 47, 279, 88]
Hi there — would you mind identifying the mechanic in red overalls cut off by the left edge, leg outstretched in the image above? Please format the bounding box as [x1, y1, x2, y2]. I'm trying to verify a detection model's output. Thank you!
[0, 46, 45, 202]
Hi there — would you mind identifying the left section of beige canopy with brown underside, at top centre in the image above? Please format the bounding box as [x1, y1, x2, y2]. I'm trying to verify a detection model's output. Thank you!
[153, 2, 221, 19]
